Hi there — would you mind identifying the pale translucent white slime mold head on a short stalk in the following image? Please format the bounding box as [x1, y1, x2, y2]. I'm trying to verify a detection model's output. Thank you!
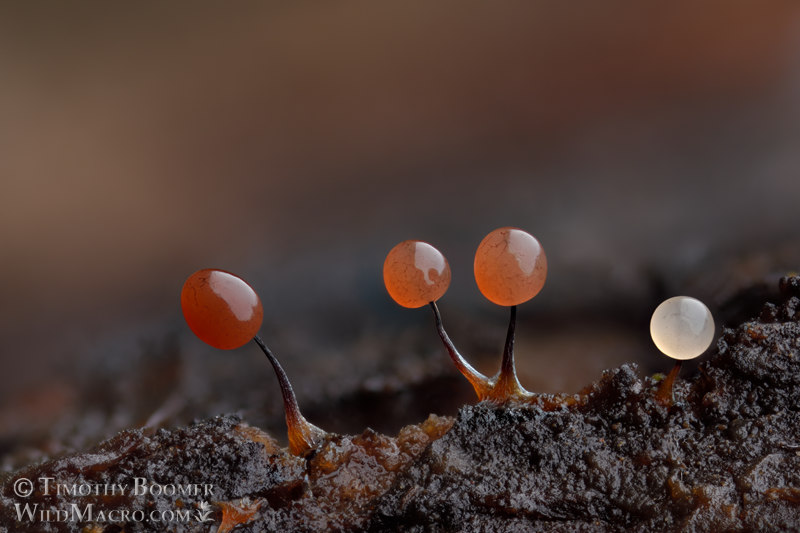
[650, 296, 714, 360]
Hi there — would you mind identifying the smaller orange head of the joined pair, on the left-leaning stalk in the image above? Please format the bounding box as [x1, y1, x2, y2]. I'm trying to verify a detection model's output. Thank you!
[383, 241, 450, 308]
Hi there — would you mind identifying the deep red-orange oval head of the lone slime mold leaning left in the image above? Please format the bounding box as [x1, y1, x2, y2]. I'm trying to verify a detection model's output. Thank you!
[181, 268, 264, 350]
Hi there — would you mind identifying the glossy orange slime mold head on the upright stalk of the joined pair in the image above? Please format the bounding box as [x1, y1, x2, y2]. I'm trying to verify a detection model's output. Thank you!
[475, 228, 547, 306]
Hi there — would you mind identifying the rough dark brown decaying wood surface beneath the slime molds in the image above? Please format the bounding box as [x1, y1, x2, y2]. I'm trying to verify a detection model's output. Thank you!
[0, 277, 800, 532]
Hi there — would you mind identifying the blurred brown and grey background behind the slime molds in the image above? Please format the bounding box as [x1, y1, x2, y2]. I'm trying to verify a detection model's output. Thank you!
[0, 1, 800, 468]
